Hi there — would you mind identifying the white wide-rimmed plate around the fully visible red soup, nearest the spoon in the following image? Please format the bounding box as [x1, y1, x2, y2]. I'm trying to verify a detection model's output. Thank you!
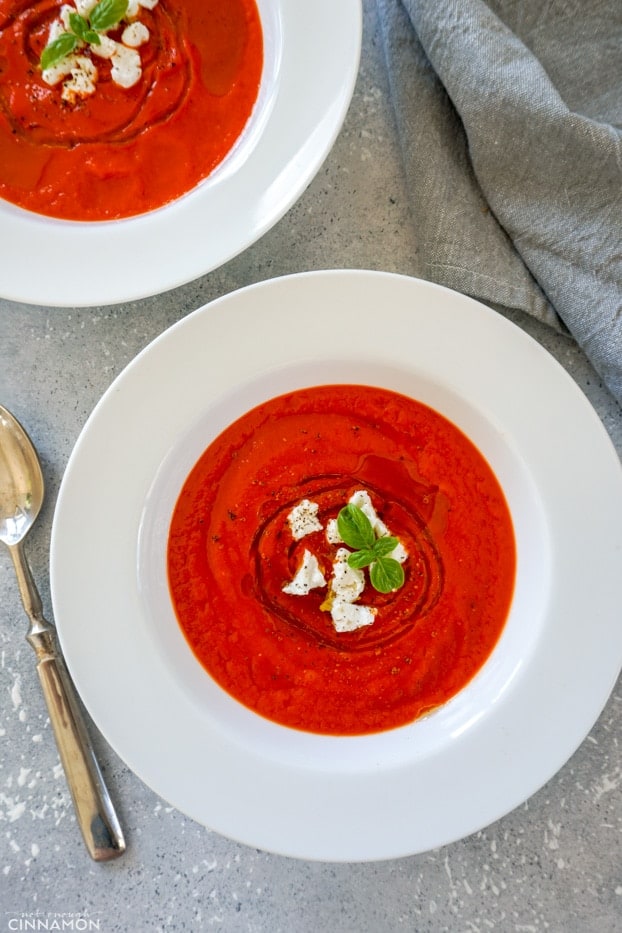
[52, 271, 622, 861]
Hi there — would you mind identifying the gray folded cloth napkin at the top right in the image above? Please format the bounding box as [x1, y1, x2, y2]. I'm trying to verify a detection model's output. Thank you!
[377, 0, 622, 403]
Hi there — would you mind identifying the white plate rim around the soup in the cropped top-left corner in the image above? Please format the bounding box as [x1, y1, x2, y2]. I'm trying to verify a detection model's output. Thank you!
[0, 0, 362, 306]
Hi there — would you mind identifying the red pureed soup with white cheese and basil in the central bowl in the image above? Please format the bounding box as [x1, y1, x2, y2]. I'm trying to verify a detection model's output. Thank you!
[168, 385, 516, 735]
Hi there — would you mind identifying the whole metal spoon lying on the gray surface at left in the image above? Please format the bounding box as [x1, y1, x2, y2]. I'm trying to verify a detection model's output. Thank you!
[0, 405, 125, 862]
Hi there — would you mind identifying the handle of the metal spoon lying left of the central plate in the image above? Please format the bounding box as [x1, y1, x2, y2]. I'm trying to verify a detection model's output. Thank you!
[9, 543, 125, 862]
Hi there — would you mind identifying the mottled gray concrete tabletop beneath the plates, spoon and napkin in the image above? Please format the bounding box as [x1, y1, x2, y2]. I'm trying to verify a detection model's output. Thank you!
[0, 0, 622, 933]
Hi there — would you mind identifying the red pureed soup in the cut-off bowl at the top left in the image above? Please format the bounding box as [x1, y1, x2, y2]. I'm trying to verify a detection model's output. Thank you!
[0, 0, 263, 221]
